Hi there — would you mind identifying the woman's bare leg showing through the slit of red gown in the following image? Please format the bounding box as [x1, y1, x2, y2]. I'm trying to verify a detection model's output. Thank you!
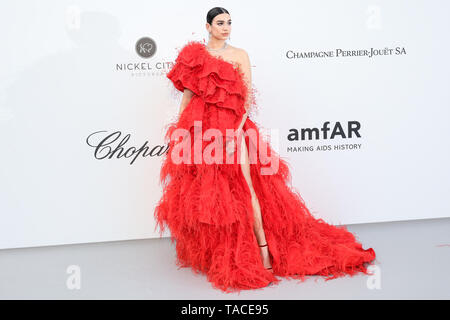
[237, 135, 272, 270]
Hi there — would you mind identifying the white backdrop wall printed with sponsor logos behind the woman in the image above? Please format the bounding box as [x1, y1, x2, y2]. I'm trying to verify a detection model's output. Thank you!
[0, 0, 450, 248]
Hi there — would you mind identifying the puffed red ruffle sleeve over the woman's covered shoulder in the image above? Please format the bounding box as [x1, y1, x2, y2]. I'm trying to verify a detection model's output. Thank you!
[166, 41, 202, 95]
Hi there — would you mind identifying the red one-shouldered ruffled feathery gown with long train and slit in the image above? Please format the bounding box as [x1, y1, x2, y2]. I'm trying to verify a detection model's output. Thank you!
[154, 41, 375, 292]
